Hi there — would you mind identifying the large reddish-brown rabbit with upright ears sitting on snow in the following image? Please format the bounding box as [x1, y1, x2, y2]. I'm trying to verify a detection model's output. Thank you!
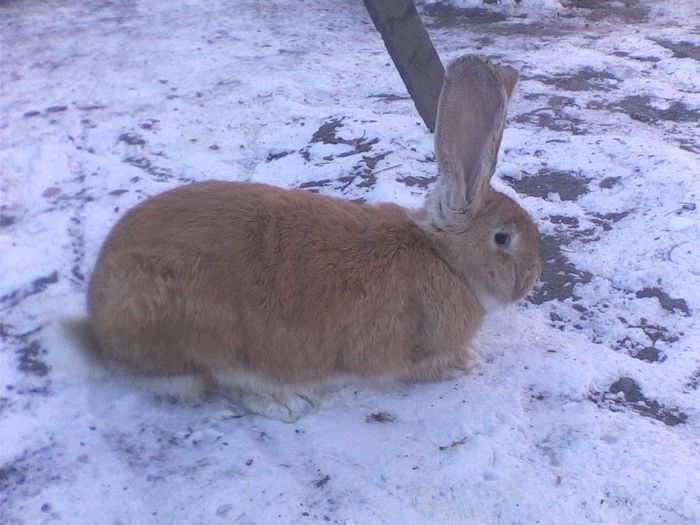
[88, 55, 541, 422]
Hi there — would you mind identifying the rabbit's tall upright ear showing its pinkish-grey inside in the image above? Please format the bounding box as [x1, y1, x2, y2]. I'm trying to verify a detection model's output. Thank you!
[431, 55, 518, 228]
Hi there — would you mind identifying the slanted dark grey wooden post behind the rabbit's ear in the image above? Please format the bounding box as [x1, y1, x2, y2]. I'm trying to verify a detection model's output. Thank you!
[364, 0, 445, 132]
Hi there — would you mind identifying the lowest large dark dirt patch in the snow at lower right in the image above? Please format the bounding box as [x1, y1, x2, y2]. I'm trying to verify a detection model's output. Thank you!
[588, 377, 688, 426]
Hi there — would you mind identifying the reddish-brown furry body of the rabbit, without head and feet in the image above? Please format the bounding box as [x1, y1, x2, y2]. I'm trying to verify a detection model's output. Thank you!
[89, 182, 483, 383]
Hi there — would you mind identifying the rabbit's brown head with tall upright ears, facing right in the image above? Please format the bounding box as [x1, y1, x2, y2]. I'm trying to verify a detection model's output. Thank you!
[416, 55, 542, 311]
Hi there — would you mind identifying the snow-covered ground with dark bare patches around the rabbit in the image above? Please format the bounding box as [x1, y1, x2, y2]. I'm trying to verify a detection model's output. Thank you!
[0, 0, 700, 525]
